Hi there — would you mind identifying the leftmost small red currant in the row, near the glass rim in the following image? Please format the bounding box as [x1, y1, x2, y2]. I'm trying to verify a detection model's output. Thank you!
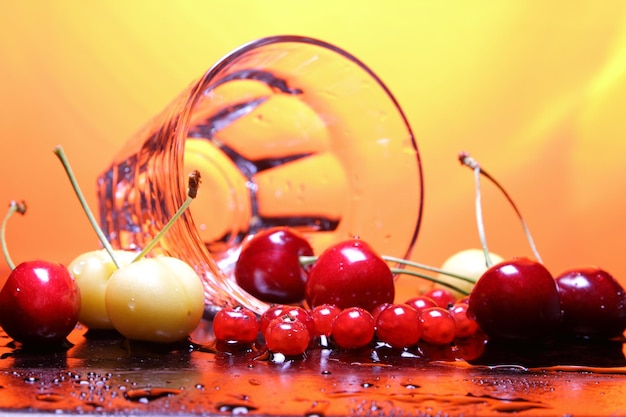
[213, 307, 259, 343]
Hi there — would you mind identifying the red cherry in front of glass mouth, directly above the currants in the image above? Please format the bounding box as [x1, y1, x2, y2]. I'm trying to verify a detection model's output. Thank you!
[306, 239, 395, 312]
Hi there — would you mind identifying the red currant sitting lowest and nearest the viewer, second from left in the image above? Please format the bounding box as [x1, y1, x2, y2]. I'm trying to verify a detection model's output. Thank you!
[265, 315, 311, 356]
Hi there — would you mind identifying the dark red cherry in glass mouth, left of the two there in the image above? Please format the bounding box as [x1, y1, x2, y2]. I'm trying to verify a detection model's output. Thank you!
[234, 227, 313, 304]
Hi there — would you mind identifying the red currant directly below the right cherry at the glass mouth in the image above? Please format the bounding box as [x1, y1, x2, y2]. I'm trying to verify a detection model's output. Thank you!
[331, 307, 374, 349]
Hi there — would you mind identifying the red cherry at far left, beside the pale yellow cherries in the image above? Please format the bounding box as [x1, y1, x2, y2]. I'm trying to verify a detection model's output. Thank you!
[0, 261, 80, 346]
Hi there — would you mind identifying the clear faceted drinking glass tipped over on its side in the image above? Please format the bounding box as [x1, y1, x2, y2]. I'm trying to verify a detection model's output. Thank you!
[98, 36, 423, 312]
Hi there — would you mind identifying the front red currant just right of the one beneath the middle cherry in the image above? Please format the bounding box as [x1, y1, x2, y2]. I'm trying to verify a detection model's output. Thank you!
[376, 304, 422, 348]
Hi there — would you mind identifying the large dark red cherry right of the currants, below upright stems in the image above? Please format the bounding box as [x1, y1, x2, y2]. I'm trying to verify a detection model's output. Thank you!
[469, 258, 561, 341]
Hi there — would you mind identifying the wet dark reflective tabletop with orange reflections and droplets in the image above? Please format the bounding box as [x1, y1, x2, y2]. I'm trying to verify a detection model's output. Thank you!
[0, 322, 626, 417]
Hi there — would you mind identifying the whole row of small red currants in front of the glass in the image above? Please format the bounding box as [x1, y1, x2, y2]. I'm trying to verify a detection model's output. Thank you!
[213, 289, 479, 356]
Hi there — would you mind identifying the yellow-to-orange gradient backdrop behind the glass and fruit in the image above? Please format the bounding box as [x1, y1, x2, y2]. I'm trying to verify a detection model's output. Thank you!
[0, 0, 626, 290]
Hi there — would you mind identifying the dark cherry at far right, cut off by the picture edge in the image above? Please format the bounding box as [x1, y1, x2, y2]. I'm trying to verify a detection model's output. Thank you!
[556, 267, 626, 338]
